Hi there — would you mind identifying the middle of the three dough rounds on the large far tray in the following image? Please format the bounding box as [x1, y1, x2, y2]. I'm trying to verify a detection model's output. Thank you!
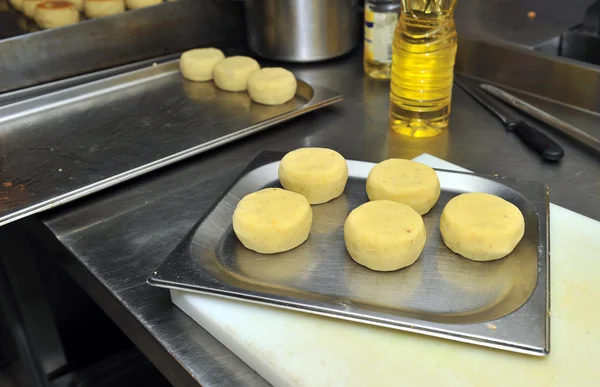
[213, 56, 260, 91]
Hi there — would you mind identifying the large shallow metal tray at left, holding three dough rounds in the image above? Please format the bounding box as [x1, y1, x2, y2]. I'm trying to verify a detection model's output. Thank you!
[0, 61, 342, 225]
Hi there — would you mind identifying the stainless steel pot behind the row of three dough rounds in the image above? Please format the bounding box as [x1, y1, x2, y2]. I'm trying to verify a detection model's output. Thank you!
[244, 0, 362, 62]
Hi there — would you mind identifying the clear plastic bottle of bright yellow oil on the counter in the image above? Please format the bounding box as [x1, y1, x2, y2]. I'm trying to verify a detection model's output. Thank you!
[390, 0, 457, 137]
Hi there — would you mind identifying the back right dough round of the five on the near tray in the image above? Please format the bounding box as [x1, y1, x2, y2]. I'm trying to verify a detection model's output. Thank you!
[367, 159, 440, 215]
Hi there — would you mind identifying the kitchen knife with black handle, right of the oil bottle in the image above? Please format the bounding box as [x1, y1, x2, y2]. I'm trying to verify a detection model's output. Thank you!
[454, 77, 565, 161]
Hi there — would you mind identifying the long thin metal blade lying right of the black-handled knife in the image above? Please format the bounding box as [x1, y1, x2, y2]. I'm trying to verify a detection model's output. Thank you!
[480, 84, 600, 158]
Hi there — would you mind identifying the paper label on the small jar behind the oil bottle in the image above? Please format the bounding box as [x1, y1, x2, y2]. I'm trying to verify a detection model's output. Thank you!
[365, 6, 398, 63]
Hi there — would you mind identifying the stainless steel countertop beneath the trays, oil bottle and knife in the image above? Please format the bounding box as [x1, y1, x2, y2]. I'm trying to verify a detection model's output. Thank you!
[30, 0, 600, 387]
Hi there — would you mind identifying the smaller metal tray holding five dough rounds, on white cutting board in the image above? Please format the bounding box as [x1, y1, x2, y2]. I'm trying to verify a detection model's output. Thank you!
[148, 152, 550, 356]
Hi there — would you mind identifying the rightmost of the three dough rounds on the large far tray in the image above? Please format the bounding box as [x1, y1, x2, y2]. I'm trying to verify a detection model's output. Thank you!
[248, 67, 298, 105]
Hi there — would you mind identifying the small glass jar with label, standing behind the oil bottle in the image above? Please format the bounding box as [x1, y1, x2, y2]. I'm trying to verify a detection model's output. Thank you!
[363, 0, 400, 79]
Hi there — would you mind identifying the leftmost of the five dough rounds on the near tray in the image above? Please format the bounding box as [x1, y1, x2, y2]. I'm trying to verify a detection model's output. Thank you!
[233, 188, 312, 254]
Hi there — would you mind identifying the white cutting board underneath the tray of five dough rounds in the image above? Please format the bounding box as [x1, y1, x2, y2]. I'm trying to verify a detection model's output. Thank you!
[171, 155, 600, 387]
